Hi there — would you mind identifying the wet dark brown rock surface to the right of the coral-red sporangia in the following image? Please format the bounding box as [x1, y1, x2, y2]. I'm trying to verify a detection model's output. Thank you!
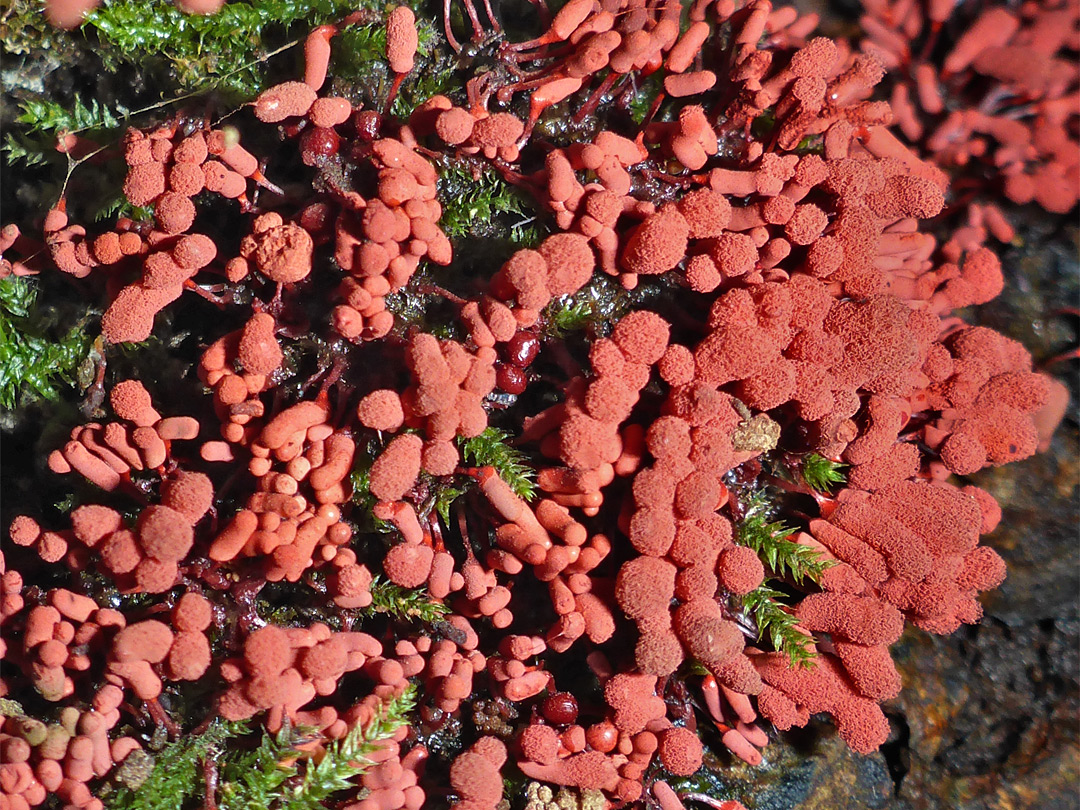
[678, 219, 1080, 810]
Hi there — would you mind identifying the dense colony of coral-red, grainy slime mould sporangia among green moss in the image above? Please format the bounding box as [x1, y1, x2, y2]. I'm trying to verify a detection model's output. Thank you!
[0, 0, 1078, 810]
